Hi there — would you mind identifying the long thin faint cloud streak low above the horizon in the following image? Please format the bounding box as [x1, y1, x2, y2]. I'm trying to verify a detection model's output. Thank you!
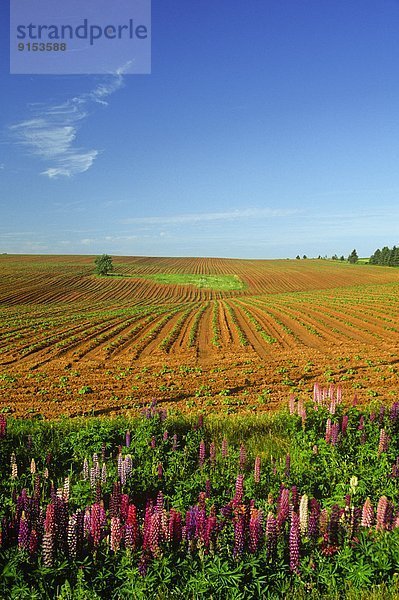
[121, 208, 301, 225]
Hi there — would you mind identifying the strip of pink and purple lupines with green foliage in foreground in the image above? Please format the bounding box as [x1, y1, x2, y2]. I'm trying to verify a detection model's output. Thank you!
[0, 386, 399, 600]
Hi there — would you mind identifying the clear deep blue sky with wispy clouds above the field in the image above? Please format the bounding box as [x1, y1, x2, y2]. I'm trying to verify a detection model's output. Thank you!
[0, 0, 399, 258]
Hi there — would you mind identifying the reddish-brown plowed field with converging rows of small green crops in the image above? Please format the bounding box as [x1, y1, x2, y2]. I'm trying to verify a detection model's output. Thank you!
[0, 255, 399, 417]
